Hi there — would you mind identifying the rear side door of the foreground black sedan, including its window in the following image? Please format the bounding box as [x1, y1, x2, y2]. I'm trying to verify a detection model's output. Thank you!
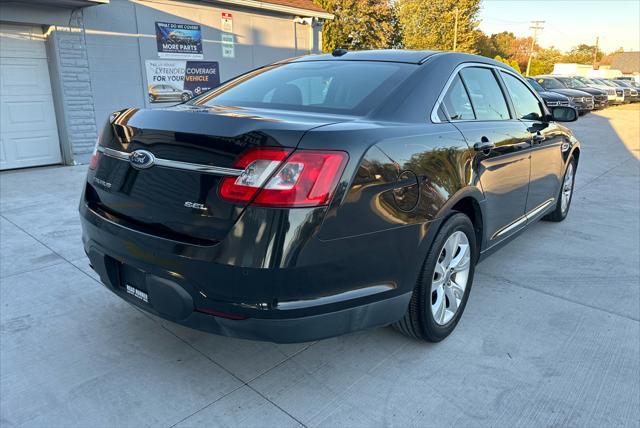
[443, 66, 531, 242]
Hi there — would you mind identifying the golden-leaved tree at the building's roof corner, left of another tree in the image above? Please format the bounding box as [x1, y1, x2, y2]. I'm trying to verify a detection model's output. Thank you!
[316, 0, 396, 52]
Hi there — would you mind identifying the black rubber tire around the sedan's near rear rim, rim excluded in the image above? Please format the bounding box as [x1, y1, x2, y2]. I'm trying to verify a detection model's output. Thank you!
[393, 213, 477, 342]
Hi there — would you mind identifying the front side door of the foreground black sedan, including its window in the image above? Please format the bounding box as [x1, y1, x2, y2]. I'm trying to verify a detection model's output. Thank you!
[500, 71, 564, 217]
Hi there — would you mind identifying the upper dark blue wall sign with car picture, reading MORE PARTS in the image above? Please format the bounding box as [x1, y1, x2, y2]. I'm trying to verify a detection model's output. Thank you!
[156, 22, 203, 59]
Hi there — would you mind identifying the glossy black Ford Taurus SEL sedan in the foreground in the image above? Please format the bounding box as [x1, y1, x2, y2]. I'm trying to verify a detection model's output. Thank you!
[80, 50, 580, 342]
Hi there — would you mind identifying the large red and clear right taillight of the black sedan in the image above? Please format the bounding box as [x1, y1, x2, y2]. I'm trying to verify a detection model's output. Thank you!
[220, 148, 347, 207]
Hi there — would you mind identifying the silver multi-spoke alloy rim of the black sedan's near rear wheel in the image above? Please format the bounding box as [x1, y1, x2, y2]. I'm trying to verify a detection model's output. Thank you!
[431, 231, 471, 325]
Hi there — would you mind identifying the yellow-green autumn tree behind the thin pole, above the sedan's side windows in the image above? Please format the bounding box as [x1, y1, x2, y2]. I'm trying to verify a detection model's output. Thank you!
[396, 0, 480, 53]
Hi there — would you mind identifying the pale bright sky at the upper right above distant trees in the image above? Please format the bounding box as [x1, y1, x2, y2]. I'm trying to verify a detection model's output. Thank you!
[479, 0, 640, 53]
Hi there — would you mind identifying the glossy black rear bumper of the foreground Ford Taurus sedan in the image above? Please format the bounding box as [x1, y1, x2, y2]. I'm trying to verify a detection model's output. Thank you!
[80, 203, 418, 343]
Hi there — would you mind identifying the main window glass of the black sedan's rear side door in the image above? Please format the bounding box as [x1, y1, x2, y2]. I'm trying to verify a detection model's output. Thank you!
[460, 67, 509, 120]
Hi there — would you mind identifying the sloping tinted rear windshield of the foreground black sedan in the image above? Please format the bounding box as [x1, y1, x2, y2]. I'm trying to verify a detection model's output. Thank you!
[189, 61, 417, 115]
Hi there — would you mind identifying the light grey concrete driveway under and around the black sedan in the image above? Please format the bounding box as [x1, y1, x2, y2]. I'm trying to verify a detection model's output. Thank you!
[0, 105, 640, 427]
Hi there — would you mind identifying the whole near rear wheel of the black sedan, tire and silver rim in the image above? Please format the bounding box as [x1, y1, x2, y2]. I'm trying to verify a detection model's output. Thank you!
[394, 213, 476, 342]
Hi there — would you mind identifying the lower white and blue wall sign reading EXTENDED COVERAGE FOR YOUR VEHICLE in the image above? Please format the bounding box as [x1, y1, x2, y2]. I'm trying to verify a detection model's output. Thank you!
[145, 59, 220, 103]
